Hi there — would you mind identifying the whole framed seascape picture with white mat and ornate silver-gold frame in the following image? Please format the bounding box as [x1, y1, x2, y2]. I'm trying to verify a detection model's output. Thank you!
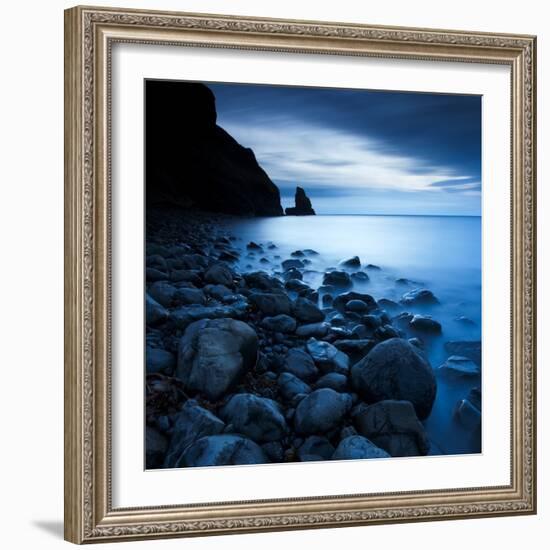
[65, 7, 536, 543]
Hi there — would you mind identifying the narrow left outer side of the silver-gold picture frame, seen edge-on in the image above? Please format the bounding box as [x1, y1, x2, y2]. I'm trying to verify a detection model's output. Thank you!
[63, 8, 84, 544]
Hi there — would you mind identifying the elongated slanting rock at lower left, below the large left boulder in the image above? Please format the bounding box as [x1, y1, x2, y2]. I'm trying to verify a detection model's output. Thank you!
[164, 399, 225, 468]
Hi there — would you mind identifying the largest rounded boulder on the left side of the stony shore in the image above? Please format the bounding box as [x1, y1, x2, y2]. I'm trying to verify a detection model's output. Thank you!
[176, 319, 258, 401]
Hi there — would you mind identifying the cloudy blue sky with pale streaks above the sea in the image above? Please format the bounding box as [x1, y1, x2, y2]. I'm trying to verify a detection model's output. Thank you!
[207, 84, 481, 215]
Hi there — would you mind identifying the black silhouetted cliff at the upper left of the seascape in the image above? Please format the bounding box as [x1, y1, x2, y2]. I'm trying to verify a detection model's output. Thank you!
[146, 80, 283, 216]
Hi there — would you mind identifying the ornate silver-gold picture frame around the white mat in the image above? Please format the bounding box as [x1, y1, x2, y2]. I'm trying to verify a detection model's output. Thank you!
[64, 7, 536, 543]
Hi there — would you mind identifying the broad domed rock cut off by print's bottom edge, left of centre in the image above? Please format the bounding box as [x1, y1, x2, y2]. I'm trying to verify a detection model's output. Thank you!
[182, 434, 269, 466]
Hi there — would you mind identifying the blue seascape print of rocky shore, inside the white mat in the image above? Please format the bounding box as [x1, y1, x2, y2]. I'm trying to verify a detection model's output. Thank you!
[144, 80, 482, 469]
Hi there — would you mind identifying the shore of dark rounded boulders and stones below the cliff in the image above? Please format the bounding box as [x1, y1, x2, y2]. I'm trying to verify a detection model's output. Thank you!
[146, 208, 481, 468]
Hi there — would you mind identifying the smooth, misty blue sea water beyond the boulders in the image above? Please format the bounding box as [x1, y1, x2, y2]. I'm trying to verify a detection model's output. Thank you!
[222, 216, 481, 454]
